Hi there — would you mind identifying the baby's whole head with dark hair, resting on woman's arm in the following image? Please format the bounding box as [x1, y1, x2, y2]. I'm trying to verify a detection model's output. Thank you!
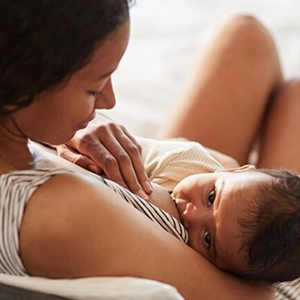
[173, 168, 300, 283]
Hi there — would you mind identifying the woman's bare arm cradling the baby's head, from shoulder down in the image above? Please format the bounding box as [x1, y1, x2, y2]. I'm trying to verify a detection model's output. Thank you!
[20, 174, 272, 300]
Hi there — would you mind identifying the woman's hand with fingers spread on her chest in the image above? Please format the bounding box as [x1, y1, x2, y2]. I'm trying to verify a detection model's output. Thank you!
[57, 115, 152, 199]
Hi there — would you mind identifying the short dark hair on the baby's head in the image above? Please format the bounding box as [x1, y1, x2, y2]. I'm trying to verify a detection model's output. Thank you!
[239, 169, 300, 283]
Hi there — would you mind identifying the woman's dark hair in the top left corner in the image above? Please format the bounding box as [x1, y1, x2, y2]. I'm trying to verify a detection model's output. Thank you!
[0, 0, 132, 116]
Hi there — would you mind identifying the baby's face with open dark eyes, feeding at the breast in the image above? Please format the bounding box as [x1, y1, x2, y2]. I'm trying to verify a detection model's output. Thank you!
[172, 170, 272, 272]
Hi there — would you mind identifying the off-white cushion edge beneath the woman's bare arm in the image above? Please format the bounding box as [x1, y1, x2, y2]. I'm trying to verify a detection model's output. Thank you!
[0, 274, 184, 300]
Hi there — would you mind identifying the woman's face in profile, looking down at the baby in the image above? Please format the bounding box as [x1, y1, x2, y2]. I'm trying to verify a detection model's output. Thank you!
[11, 21, 130, 145]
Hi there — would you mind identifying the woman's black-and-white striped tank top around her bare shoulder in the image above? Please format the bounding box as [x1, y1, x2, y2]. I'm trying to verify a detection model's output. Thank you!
[0, 168, 188, 276]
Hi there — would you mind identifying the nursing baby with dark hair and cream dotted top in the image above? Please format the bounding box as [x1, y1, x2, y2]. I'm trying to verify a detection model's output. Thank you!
[137, 138, 300, 283]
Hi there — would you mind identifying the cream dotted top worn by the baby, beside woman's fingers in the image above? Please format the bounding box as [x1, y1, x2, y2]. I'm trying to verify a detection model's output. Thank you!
[135, 137, 224, 191]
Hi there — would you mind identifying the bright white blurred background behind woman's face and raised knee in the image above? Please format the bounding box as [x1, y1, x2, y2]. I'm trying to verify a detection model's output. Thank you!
[105, 0, 300, 137]
